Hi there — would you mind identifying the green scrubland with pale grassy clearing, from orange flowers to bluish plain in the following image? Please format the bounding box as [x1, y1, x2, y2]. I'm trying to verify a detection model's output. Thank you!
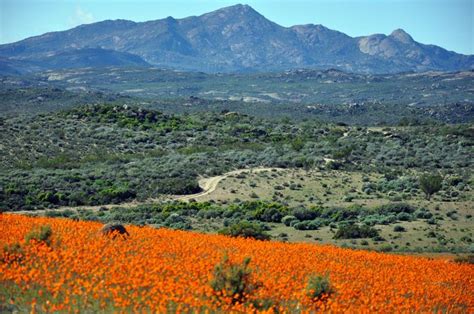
[0, 105, 474, 253]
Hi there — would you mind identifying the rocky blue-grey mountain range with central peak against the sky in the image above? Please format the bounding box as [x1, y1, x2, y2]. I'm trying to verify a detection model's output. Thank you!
[0, 4, 474, 74]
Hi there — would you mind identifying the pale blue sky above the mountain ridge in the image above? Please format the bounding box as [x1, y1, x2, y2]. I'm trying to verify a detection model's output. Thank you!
[0, 0, 474, 54]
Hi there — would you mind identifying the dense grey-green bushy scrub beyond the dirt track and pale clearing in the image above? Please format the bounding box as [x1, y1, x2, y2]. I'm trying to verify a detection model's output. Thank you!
[0, 105, 473, 209]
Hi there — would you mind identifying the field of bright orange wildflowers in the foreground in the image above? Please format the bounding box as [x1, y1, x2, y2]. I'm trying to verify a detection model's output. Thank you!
[0, 214, 474, 313]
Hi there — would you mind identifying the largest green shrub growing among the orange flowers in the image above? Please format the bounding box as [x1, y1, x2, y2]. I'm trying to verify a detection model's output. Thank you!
[210, 255, 254, 303]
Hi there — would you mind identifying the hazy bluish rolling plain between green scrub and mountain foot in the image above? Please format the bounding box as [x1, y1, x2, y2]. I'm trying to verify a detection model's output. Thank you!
[0, 67, 474, 125]
